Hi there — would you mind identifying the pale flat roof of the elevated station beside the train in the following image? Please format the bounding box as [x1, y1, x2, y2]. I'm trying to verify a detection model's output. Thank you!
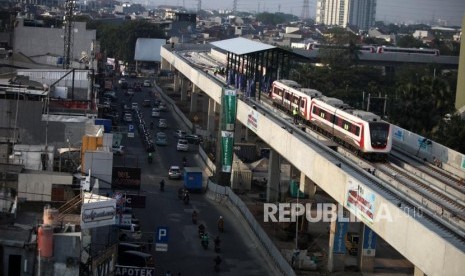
[211, 37, 276, 55]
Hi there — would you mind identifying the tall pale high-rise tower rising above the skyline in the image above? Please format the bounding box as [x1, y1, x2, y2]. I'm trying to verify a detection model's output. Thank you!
[316, 0, 376, 30]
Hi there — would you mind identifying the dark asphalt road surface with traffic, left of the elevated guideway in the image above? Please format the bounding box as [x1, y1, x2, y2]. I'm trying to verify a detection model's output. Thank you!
[115, 78, 278, 276]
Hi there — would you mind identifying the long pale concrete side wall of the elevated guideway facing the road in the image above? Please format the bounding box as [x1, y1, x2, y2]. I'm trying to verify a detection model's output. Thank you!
[161, 44, 465, 275]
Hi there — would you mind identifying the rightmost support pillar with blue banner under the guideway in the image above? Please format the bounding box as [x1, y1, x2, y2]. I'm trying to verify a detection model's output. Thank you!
[358, 225, 377, 272]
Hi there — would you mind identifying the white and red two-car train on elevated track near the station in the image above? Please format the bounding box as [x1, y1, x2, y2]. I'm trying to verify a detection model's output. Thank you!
[270, 80, 392, 161]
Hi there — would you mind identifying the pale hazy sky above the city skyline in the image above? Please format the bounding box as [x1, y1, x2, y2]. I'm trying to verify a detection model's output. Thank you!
[152, 0, 465, 26]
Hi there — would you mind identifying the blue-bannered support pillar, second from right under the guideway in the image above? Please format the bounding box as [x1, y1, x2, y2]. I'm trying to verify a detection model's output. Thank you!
[327, 215, 348, 272]
